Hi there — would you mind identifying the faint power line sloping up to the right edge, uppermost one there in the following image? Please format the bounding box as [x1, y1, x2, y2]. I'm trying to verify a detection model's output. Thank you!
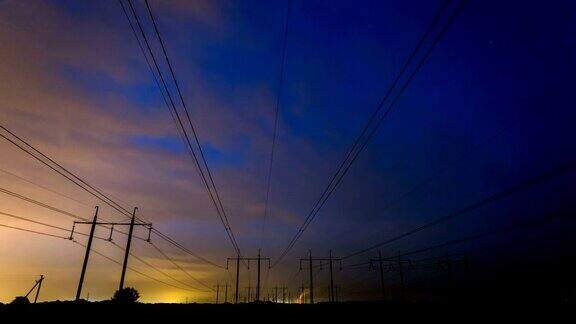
[342, 162, 576, 259]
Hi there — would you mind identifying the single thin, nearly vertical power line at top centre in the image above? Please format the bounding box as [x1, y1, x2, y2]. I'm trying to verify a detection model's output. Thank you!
[262, 0, 292, 248]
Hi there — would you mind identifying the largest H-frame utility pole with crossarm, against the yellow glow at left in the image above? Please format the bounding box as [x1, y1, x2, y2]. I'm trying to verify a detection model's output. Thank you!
[68, 206, 152, 294]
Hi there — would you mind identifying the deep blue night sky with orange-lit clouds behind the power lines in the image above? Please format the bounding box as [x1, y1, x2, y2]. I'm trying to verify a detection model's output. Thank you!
[0, 0, 576, 302]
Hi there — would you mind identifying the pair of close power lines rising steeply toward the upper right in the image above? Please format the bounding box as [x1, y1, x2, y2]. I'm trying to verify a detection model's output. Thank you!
[274, 0, 467, 265]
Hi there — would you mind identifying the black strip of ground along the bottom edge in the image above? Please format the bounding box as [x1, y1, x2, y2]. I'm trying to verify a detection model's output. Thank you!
[0, 302, 576, 323]
